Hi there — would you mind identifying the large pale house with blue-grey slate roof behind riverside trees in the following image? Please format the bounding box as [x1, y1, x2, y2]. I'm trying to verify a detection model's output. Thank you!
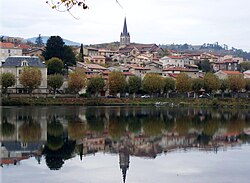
[1, 56, 47, 93]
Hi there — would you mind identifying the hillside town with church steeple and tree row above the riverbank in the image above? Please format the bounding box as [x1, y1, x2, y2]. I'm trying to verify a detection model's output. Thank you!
[0, 18, 250, 98]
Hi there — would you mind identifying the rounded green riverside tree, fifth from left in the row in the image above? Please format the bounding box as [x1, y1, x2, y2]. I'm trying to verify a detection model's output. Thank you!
[87, 76, 105, 96]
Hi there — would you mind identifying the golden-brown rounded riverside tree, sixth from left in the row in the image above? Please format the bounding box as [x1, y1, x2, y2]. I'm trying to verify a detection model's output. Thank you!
[108, 71, 127, 95]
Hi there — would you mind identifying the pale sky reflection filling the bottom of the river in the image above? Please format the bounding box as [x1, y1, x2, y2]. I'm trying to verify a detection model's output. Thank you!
[0, 145, 250, 183]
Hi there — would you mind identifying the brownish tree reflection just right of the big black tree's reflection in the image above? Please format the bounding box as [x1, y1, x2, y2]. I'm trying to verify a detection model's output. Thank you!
[68, 118, 86, 140]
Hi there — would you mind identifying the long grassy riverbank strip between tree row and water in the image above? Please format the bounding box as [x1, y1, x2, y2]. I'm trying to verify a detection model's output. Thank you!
[2, 97, 250, 108]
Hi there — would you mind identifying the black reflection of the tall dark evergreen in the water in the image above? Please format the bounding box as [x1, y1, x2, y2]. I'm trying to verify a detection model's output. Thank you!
[43, 139, 75, 170]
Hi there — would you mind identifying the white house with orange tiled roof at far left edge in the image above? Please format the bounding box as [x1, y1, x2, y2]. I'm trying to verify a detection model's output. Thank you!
[0, 42, 23, 66]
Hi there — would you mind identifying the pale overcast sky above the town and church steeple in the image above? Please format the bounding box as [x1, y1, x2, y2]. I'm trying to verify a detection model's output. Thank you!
[0, 0, 250, 52]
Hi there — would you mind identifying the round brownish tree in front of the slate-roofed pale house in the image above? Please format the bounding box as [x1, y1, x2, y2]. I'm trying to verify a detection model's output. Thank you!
[19, 67, 42, 94]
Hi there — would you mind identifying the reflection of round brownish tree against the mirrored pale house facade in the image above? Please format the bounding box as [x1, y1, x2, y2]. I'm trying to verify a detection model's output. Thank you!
[19, 118, 42, 142]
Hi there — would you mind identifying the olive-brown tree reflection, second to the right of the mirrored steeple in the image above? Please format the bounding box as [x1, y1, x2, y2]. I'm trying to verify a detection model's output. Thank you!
[143, 117, 165, 136]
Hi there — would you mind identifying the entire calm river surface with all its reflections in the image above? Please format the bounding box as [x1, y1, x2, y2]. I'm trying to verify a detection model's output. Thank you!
[0, 106, 250, 183]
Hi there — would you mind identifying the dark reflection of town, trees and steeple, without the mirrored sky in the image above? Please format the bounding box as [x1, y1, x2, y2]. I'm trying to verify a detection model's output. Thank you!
[1, 107, 250, 182]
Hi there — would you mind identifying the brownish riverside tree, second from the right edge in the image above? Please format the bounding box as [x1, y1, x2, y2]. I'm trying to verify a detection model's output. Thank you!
[228, 76, 246, 92]
